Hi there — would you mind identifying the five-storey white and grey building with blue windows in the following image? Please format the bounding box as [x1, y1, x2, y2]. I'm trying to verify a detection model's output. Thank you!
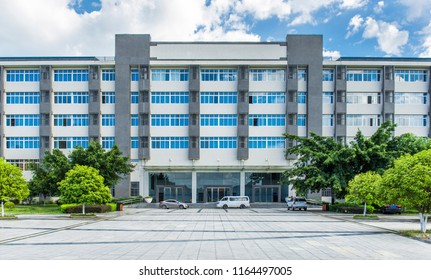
[0, 35, 431, 203]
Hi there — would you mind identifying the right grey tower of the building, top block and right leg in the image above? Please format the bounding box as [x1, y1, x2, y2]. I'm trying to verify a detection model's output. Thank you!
[286, 35, 323, 135]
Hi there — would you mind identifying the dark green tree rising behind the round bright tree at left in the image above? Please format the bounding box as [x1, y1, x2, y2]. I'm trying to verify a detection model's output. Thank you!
[69, 141, 134, 187]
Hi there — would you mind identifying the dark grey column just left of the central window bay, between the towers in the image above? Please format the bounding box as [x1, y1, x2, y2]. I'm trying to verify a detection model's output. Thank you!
[189, 65, 200, 160]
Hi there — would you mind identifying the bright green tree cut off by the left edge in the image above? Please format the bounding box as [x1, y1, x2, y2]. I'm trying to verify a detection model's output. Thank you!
[0, 158, 30, 217]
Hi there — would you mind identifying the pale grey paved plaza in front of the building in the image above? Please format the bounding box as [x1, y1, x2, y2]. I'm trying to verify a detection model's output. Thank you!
[0, 208, 431, 260]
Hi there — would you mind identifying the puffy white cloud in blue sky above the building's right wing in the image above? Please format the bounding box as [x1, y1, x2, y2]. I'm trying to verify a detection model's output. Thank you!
[362, 17, 409, 55]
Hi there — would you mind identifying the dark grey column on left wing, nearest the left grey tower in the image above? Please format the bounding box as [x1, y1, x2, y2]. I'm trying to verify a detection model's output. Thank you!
[88, 65, 101, 142]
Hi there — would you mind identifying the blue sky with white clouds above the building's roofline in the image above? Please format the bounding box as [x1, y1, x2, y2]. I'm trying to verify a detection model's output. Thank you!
[0, 0, 431, 58]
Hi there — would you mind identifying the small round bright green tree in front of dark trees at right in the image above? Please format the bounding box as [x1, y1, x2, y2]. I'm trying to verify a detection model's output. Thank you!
[346, 171, 382, 216]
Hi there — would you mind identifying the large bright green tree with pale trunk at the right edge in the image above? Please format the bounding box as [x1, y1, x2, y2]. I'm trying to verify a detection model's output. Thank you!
[383, 150, 431, 233]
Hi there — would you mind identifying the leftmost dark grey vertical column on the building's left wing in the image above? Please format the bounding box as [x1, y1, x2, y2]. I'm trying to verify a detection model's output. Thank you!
[39, 65, 53, 160]
